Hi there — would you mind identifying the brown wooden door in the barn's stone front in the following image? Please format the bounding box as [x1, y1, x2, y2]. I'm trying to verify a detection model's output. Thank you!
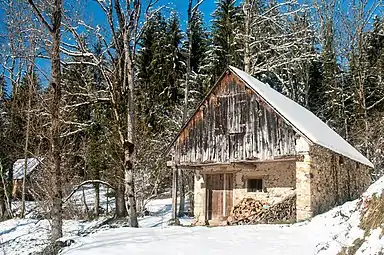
[206, 173, 233, 220]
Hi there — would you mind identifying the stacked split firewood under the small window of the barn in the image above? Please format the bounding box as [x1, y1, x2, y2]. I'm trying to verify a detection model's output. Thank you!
[227, 195, 296, 225]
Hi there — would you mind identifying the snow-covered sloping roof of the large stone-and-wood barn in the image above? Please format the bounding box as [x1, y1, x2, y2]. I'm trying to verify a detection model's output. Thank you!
[230, 66, 373, 168]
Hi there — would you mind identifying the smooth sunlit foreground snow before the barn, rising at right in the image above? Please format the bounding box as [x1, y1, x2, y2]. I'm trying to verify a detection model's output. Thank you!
[62, 177, 384, 255]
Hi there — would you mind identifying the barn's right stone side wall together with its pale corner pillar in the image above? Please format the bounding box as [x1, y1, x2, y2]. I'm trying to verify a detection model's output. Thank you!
[296, 139, 371, 221]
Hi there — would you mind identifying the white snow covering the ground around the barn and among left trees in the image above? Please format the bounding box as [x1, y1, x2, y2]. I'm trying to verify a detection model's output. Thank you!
[0, 177, 384, 255]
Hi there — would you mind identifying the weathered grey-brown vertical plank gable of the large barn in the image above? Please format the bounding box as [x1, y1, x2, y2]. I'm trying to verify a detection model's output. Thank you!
[173, 70, 295, 165]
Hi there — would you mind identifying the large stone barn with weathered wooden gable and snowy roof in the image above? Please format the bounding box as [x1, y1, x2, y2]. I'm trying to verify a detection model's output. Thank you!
[169, 67, 373, 224]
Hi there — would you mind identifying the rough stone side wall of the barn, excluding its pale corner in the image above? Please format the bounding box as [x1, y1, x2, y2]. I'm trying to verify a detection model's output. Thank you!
[309, 145, 371, 215]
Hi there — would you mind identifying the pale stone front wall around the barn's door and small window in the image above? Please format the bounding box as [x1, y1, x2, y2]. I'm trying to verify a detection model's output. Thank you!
[194, 159, 296, 224]
